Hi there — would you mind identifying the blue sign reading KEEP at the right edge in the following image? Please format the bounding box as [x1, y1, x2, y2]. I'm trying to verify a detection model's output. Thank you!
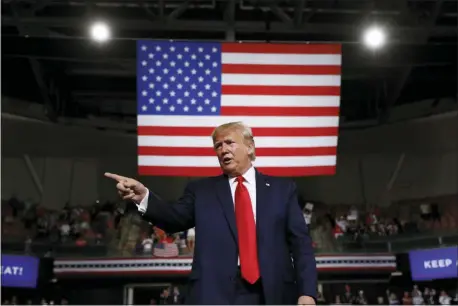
[409, 246, 458, 281]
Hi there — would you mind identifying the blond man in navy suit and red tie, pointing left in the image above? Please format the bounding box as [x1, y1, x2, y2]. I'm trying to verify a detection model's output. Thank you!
[105, 122, 317, 305]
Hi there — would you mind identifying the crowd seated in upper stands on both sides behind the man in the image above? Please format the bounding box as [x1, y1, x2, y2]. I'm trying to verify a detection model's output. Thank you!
[2, 196, 458, 257]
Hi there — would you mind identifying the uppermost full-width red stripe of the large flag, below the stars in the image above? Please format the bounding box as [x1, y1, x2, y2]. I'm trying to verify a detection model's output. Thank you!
[137, 126, 339, 137]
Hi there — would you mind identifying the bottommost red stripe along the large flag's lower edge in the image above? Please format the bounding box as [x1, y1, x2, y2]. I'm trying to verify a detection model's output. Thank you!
[138, 166, 336, 176]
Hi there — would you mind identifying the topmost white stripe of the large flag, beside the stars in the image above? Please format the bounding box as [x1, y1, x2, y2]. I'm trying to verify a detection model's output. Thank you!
[221, 52, 342, 66]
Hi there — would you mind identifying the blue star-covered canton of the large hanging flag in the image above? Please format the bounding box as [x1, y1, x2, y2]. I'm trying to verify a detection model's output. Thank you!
[137, 41, 222, 116]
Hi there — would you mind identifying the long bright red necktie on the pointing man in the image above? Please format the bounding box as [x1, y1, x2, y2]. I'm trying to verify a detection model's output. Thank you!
[235, 176, 259, 284]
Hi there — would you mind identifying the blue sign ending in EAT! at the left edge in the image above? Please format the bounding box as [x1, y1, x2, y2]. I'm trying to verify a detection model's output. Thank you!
[1, 254, 40, 288]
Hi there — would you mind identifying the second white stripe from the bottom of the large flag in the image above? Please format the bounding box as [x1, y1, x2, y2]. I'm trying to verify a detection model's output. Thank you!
[138, 135, 337, 148]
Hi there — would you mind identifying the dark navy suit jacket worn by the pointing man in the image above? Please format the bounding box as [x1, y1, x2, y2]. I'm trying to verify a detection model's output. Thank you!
[143, 171, 317, 304]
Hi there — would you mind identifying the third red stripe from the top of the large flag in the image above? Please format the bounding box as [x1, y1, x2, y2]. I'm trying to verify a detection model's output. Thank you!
[221, 85, 340, 96]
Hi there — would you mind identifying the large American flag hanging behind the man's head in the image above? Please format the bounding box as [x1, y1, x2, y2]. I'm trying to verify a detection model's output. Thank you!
[137, 40, 341, 176]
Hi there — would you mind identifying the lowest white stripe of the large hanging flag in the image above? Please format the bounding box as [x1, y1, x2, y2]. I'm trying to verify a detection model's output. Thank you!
[138, 155, 337, 167]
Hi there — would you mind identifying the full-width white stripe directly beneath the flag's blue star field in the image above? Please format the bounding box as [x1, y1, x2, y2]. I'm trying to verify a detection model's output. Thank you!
[137, 115, 339, 128]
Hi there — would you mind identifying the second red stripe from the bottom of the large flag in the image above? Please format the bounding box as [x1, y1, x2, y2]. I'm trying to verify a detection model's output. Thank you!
[138, 146, 337, 156]
